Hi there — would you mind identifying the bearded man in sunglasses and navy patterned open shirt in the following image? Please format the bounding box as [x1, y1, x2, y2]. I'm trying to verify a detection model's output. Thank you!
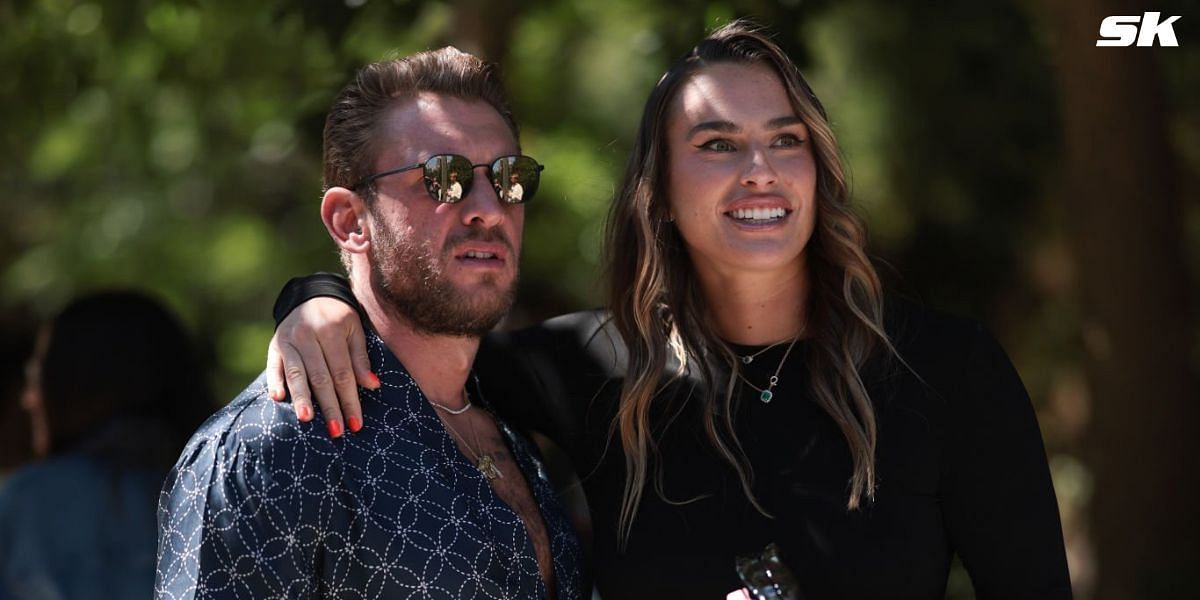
[155, 48, 581, 598]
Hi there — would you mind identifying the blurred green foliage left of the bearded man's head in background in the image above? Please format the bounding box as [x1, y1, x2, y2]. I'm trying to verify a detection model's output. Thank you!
[0, 1, 360, 394]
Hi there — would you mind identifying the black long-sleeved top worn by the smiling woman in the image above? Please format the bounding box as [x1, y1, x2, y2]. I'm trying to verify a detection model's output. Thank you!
[276, 276, 1070, 600]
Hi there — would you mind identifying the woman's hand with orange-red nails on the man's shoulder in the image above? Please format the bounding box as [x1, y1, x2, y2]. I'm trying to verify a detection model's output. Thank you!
[266, 296, 379, 438]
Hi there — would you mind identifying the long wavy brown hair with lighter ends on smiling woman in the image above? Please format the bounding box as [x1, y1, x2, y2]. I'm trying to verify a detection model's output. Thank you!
[605, 20, 895, 546]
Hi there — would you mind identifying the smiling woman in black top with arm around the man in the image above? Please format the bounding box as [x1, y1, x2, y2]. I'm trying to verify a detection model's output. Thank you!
[268, 22, 1070, 599]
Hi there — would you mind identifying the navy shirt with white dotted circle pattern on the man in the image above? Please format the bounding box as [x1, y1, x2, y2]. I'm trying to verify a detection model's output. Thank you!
[155, 332, 582, 599]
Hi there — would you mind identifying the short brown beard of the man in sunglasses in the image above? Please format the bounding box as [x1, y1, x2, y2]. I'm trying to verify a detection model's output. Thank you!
[370, 216, 516, 337]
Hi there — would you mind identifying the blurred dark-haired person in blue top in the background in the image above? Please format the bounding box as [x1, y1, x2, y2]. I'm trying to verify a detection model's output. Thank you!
[0, 293, 211, 600]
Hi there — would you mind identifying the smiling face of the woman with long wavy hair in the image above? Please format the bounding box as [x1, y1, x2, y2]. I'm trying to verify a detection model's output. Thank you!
[667, 62, 816, 281]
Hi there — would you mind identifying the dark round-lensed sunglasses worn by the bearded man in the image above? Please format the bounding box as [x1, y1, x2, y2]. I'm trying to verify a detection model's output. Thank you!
[353, 154, 546, 204]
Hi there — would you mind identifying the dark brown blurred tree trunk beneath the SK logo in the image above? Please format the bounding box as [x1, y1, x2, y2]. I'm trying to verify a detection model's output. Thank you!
[1036, 0, 1200, 600]
